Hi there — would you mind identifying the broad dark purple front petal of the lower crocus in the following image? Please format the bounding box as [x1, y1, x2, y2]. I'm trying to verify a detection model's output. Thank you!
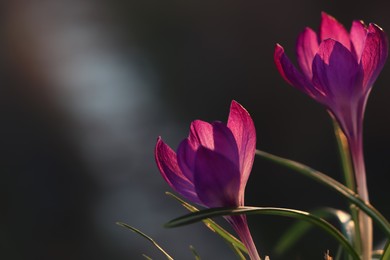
[194, 147, 243, 207]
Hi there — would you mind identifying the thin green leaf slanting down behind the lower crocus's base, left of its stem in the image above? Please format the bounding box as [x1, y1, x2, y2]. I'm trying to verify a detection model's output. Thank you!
[165, 192, 248, 254]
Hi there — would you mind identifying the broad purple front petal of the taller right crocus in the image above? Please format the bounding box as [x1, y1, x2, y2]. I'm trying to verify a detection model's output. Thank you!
[313, 39, 360, 98]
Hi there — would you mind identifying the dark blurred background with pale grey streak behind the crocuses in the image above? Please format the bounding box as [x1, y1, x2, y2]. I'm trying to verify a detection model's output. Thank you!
[0, 0, 390, 260]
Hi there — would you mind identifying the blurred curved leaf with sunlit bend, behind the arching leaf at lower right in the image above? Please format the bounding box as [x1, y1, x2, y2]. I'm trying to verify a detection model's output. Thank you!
[275, 208, 353, 256]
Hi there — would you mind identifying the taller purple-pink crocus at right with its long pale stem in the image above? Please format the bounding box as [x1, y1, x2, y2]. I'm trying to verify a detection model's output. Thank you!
[274, 12, 388, 259]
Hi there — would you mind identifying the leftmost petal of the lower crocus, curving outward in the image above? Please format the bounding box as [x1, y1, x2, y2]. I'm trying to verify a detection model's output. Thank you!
[155, 137, 202, 204]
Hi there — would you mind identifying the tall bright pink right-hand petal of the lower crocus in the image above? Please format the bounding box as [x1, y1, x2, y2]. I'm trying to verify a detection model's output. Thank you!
[227, 100, 256, 189]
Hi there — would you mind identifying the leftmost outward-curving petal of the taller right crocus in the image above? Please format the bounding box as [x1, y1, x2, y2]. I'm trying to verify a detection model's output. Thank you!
[274, 44, 316, 98]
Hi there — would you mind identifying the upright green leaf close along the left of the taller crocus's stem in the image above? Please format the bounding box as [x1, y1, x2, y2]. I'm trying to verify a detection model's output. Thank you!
[333, 119, 363, 253]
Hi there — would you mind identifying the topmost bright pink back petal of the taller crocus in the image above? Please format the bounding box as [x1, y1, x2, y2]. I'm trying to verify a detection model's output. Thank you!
[319, 12, 351, 50]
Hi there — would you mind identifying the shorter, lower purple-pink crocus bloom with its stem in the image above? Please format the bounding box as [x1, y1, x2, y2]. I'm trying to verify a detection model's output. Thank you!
[155, 101, 260, 259]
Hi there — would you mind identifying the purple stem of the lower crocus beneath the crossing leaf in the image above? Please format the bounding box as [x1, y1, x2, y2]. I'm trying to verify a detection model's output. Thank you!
[226, 215, 261, 260]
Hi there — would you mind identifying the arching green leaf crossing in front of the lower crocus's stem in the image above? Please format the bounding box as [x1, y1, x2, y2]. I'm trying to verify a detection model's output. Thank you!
[165, 207, 360, 260]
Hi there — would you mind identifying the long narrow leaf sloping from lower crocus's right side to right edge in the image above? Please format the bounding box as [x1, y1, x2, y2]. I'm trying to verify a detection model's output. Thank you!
[256, 150, 390, 238]
